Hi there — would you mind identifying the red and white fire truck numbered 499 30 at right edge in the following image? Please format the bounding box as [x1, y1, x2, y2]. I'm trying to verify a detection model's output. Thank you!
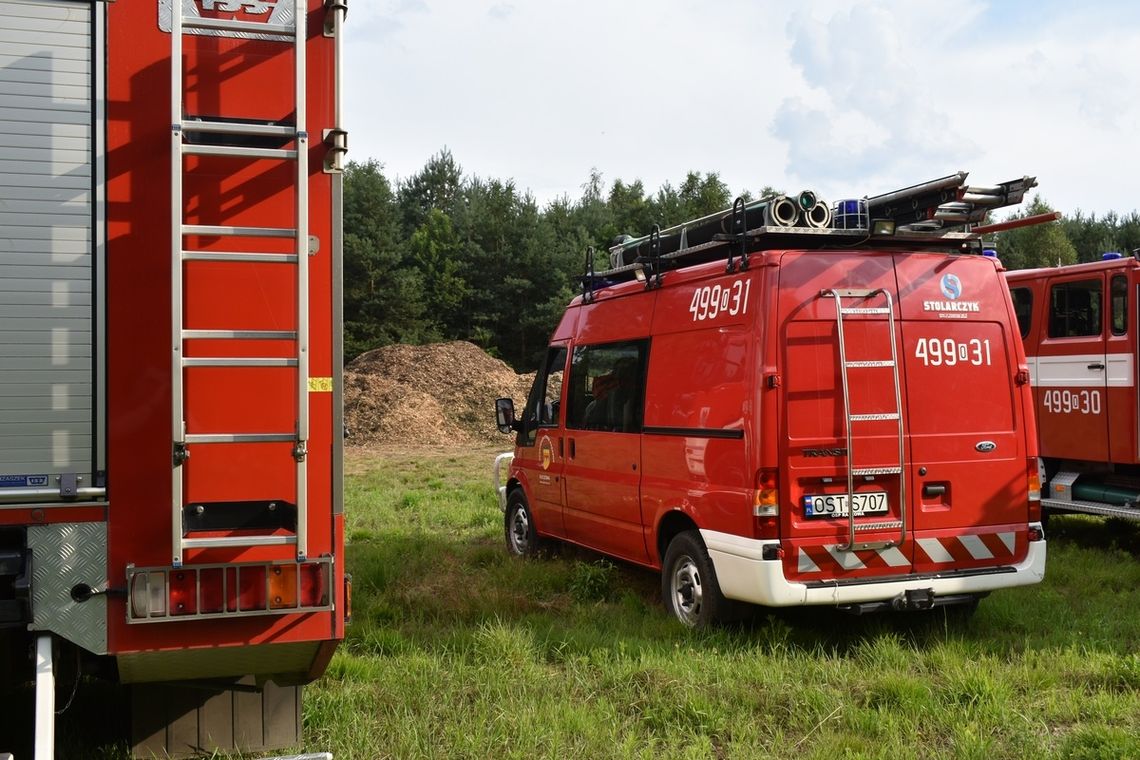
[1005, 253, 1140, 520]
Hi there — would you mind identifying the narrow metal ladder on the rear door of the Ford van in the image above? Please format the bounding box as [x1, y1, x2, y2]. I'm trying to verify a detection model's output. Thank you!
[820, 288, 906, 551]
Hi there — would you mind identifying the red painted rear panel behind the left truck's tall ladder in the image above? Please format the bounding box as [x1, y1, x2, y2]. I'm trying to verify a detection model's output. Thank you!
[99, 0, 343, 675]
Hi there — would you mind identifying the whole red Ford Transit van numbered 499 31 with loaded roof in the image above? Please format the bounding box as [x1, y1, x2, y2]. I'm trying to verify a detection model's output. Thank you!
[496, 174, 1045, 626]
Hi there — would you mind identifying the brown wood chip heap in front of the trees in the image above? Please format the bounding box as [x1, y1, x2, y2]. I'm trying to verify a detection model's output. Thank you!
[344, 341, 535, 446]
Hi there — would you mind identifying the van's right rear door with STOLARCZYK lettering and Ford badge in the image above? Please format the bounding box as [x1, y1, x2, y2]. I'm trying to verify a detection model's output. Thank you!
[895, 254, 1033, 572]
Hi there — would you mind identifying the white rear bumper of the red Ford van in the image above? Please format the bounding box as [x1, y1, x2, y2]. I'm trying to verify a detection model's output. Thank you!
[701, 530, 1045, 607]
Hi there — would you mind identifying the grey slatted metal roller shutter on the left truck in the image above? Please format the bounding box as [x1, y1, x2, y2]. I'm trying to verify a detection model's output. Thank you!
[0, 0, 101, 501]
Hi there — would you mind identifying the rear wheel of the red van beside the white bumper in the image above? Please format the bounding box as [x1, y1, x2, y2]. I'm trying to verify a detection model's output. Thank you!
[661, 531, 732, 628]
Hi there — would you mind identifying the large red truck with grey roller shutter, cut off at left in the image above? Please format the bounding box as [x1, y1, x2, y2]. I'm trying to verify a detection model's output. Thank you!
[0, 0, 348, 758]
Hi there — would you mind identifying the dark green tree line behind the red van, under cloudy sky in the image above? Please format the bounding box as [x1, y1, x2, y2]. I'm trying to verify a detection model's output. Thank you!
[344, 150, 1140, 370]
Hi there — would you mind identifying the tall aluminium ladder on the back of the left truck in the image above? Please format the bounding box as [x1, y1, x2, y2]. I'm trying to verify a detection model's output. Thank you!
[170, 0, 309, 567]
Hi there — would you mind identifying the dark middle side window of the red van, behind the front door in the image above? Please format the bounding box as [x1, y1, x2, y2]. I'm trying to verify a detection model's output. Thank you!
[567, 341, 649, 433]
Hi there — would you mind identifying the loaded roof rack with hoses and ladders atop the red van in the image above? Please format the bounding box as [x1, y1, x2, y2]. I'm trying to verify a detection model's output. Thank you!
[581, 172, 1037, 302]
